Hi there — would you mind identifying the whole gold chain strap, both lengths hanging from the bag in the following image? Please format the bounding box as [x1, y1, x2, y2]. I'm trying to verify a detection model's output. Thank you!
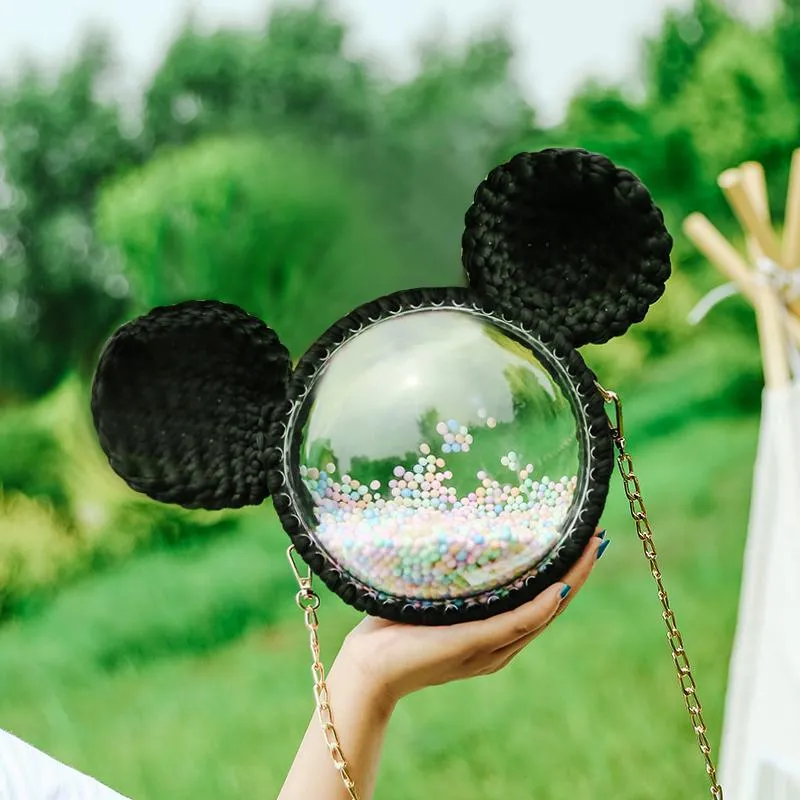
[287, 383, 723, 800]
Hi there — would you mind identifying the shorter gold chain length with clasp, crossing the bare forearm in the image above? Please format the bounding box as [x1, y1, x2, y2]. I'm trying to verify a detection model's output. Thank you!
[286, 545, 359, 800]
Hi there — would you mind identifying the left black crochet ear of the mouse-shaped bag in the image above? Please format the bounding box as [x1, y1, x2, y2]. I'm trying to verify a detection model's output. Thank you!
[92, 301, 291, 510]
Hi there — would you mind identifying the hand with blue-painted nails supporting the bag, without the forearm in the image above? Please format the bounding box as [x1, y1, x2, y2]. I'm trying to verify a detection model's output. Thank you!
[335, 535, 602, 705]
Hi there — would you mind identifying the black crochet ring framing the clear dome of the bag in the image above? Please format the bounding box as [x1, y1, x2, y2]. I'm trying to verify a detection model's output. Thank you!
[267, 289, 614, 625]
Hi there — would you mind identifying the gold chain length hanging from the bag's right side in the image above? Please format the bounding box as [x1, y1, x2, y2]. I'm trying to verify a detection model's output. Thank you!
[597, 384, 722, 800]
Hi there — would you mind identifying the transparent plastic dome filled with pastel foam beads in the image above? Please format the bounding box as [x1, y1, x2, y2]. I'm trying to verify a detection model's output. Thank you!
[294, 309, 582, 600]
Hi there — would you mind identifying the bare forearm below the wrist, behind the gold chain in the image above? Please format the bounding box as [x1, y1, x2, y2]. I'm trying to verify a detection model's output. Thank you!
[278, 656, 394, 800]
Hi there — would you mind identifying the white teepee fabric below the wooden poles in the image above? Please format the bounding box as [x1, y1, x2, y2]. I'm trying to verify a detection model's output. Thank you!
[720, 382, 800, 800]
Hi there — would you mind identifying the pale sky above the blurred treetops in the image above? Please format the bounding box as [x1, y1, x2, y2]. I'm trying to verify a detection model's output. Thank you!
[0, 0, 712, 122]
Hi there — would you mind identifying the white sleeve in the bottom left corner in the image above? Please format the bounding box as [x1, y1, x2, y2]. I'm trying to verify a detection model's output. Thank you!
[0, 730, 131, 800]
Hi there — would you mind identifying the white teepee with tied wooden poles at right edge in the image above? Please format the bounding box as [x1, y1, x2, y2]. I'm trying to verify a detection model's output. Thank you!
[684, 149, 800, 800]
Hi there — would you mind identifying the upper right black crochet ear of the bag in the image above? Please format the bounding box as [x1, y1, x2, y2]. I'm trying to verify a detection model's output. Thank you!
[462, 148, 672, 347]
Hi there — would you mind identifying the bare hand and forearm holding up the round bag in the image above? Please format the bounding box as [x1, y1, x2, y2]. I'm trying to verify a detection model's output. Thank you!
[278, 535, 608, 800]
